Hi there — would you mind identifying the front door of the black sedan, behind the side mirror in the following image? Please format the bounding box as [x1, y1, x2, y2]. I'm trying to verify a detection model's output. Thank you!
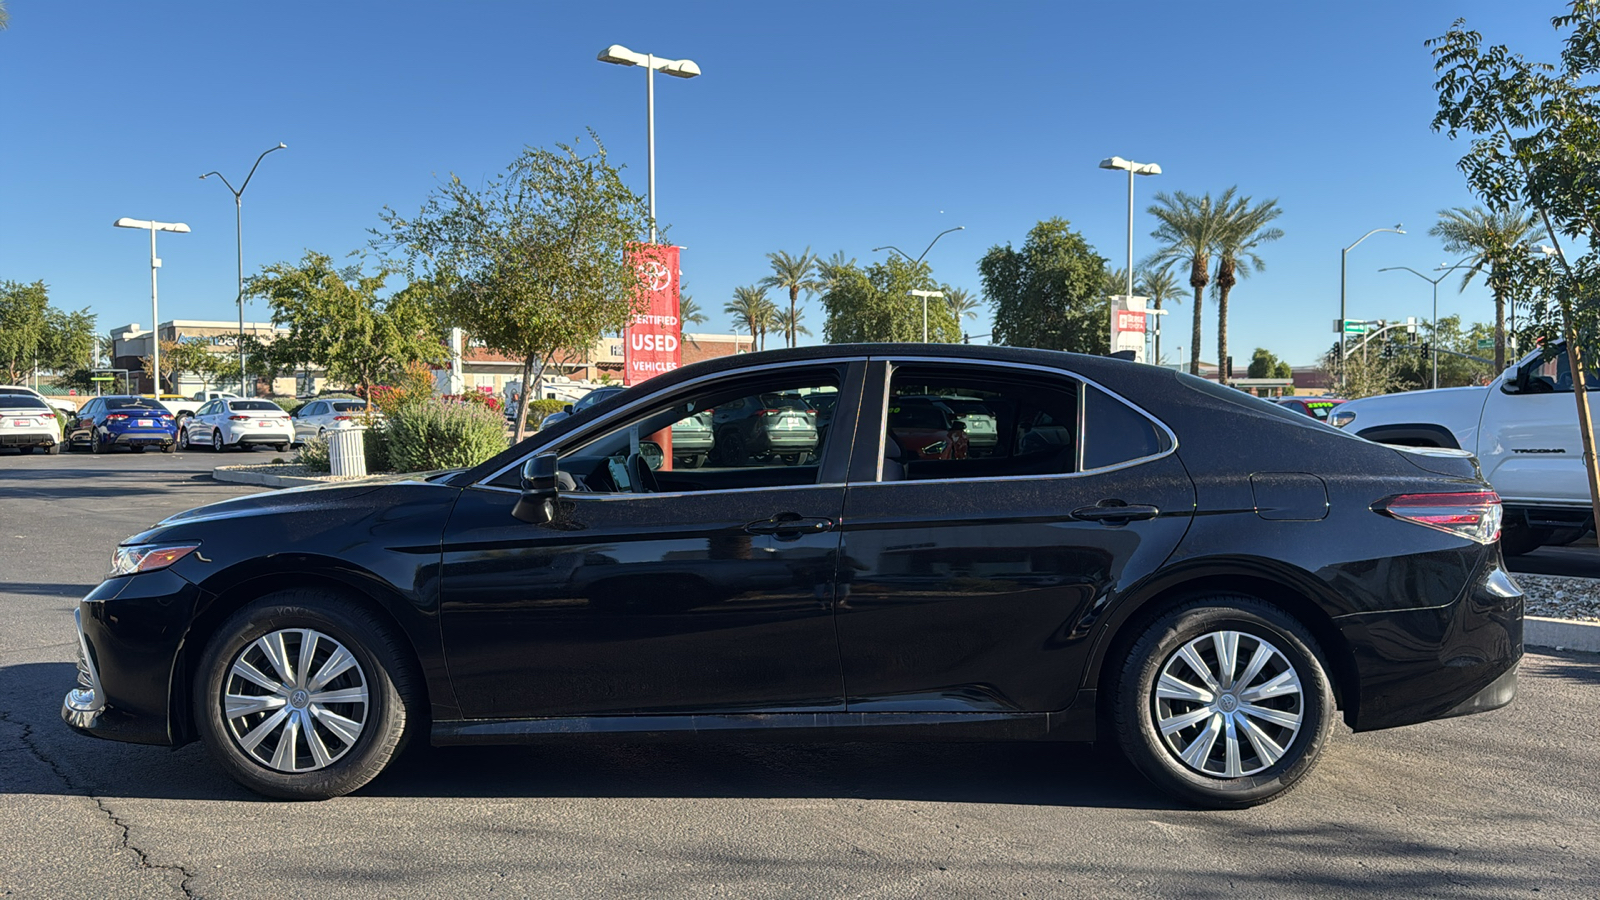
[440, 360, 861, 717]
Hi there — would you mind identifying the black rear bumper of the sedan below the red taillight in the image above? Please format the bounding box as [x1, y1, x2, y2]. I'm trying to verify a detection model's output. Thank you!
[1334, 552, 1523, 732]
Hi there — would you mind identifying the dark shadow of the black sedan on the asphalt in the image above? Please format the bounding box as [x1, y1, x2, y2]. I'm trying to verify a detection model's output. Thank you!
[0, 663, 1184, 810]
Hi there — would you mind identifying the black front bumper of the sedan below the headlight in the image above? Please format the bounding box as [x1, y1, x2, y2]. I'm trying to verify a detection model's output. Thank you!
[61, 569, 200, 746]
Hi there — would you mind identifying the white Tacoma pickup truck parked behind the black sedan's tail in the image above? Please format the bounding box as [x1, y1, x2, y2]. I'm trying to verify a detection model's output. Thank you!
[1328, 342, 1600, 556]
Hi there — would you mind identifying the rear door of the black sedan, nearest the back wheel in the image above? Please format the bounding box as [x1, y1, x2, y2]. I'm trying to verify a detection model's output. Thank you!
[837, 359, 1194, 713]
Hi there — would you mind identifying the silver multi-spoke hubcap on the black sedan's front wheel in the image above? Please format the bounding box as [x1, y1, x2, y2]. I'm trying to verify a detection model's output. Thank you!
[222, 628, 368, 772]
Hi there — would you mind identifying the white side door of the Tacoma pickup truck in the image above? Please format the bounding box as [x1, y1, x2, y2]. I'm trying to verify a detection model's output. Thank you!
[1477, 349, 1600, 506]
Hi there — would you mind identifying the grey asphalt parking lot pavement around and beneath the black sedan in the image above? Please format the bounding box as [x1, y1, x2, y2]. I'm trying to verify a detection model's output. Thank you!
[0, 452, 1600, 898]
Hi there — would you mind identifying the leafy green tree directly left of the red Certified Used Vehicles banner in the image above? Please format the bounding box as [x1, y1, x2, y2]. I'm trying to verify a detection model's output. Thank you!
[378, 133, 648, 440]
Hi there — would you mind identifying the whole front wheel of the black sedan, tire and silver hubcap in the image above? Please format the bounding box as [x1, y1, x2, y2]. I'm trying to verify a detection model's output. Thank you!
[194, 589, 421, 799]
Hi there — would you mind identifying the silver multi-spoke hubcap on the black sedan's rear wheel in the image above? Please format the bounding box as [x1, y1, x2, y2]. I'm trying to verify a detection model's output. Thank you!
[1150, 631, 1306, 778]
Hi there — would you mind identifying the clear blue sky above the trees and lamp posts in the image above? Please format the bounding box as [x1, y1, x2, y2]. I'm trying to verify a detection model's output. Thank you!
[0, 0, 1563, 365]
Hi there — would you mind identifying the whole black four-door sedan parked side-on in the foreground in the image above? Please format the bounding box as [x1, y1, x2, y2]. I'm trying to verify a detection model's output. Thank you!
[62, 344, 1522, 807]
